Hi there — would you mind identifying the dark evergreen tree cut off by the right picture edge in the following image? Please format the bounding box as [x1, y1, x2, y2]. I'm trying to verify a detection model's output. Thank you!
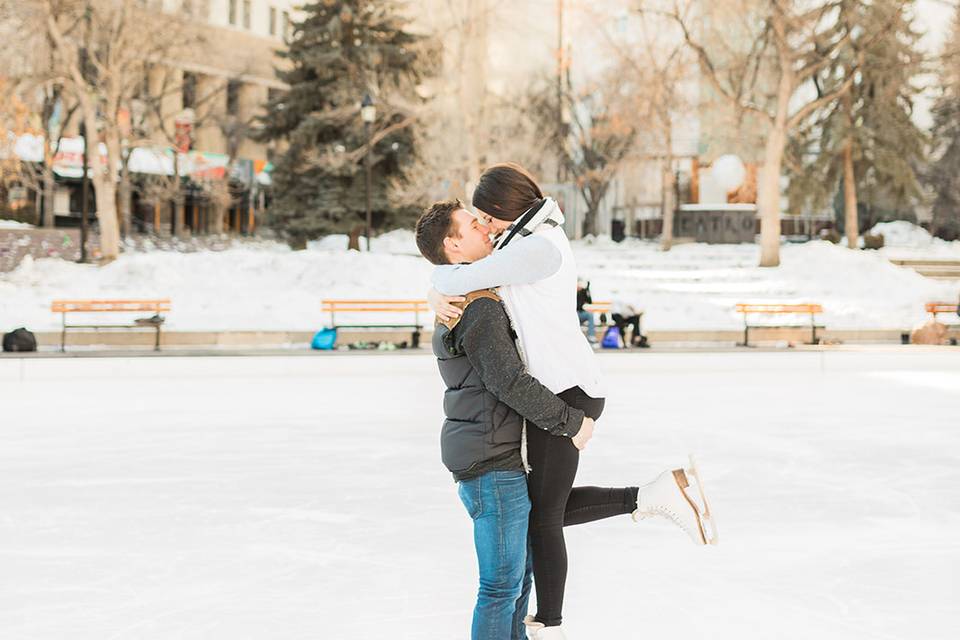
[926, 10, 960, 240]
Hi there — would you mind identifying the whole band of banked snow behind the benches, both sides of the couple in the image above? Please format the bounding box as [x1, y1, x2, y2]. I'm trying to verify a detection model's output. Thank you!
[0, 230, 960, 331]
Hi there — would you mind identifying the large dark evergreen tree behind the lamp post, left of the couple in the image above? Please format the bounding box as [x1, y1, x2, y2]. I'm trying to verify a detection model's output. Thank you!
[257, 0, 425, 246]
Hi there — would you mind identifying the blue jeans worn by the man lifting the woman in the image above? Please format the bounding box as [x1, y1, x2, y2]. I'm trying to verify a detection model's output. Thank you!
[458, 471, 533, 640]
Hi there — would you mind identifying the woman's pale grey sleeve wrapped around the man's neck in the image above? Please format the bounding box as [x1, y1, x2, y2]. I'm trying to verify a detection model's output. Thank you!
[432, 235, 563, 296]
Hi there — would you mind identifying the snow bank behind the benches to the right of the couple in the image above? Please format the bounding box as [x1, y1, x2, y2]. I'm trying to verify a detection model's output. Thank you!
[574, 240, 960, 330]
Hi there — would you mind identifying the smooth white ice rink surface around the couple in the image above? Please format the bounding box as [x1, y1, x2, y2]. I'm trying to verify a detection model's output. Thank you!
[0, 349, 960, 640]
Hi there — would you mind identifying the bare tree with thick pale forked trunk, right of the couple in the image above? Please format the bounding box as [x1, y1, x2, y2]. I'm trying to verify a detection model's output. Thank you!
[640, 0, 854, 267]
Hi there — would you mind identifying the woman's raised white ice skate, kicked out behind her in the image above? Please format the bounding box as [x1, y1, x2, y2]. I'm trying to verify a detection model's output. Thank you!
[633, 456, 719, 545]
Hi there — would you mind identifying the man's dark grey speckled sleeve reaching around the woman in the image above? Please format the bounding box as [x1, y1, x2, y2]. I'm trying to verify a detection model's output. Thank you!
[456, 298, 584, 437]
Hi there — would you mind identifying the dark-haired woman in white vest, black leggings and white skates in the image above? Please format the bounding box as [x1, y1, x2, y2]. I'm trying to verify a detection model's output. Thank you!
[430, 163, 715, 639]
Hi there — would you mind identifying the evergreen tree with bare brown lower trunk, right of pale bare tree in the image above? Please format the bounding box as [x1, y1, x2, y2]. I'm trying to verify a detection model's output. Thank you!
[789, 0, 926, 248]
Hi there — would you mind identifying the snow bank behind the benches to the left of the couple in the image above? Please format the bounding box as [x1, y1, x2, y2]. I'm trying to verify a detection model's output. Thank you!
[0, 243, 430, 331]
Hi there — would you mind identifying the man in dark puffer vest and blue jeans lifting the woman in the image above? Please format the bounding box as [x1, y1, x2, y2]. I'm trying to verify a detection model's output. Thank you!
[416, 200, 594, 640]
